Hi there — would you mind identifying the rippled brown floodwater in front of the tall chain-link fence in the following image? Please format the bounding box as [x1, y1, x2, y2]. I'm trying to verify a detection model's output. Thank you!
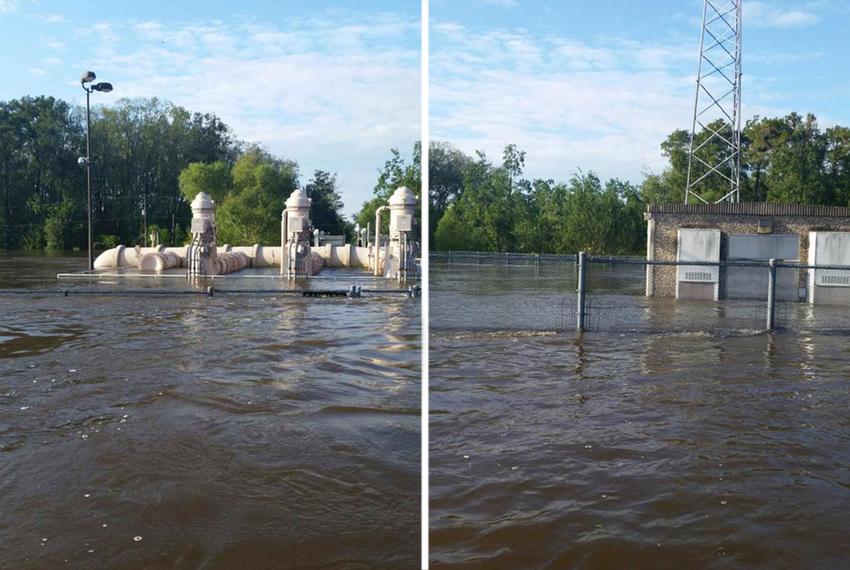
[430, 323, 850, 569]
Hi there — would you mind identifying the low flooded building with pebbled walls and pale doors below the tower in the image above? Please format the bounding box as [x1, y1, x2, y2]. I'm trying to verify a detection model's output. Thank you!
[646, 202, 850, 304]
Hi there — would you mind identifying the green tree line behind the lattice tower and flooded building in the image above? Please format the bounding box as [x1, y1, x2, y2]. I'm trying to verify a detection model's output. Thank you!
[429, 113, 850, 255]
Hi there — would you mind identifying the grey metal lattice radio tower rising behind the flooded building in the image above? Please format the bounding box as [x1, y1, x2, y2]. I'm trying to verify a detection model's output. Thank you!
[685, 0, 743, 204]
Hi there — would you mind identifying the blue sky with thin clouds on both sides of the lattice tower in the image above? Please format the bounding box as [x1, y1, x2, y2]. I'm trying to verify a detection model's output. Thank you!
[430, 0, 850, 184]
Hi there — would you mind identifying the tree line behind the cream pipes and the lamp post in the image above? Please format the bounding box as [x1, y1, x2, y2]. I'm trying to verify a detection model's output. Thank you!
[0, 96, 410, 250]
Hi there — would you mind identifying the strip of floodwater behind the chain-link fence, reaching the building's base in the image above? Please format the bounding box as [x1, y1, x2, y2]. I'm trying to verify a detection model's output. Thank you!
[430, 256, 850, 335]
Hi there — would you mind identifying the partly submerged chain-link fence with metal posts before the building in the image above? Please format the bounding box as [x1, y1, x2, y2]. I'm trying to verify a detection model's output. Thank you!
[429, 252, 850, 334]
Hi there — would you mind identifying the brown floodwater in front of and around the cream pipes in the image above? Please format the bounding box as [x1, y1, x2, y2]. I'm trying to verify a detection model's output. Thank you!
[0, 256, 420, 569]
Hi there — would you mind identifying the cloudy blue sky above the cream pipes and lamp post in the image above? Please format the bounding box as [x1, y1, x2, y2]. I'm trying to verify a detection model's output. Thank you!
[0, 0, 421, 214]
